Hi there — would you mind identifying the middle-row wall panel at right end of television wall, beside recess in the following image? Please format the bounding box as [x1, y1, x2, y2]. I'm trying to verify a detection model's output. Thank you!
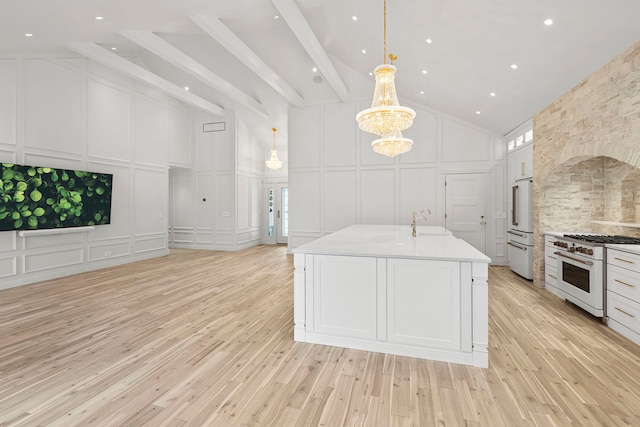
[133, 169, 168, 235]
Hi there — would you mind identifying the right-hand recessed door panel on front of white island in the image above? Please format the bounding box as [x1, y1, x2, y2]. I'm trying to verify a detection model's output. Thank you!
[387, 259, 471, 351]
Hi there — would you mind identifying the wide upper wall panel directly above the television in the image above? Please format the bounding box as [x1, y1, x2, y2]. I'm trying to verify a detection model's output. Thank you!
[23, 59, 86, 154]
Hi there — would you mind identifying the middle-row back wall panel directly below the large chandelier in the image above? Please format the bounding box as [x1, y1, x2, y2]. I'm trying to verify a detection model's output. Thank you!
[360, 169, 396, 224]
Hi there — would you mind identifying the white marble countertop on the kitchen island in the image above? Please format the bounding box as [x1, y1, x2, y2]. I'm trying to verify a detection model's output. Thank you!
[293, 224, 491, 263]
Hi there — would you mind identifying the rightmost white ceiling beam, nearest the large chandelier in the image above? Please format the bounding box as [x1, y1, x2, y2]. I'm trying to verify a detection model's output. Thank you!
[271, 0, 350, 103]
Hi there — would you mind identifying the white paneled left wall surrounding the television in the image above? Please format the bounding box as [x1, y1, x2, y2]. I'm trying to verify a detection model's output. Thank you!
[0, 57, 192, 288]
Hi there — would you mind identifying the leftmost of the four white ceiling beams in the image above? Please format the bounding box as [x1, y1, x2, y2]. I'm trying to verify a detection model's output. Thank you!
[67, 43, 225, 116]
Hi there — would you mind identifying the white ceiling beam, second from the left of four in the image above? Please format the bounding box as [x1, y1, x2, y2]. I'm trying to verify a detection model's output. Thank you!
[120, 31, 267, 117]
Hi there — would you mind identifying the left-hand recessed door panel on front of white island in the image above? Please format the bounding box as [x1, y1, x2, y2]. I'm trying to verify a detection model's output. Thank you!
[307, 255, 377, 339]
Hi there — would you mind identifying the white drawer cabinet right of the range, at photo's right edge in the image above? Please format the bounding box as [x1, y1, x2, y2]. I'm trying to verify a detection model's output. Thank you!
[607, 249, 640, 345]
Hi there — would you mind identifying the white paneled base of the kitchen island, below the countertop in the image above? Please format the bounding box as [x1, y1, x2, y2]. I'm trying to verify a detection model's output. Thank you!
[294, 253, 489, 368]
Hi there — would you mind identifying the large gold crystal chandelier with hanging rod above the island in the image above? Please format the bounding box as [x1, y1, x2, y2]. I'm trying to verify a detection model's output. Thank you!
[356, 0, 416, 157]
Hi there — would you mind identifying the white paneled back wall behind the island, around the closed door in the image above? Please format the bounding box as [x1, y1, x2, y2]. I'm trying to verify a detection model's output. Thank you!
[289, 100, 507, 264]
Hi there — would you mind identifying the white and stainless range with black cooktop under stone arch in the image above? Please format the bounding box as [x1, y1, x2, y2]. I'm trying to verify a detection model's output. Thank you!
[554, 234, 640, 318]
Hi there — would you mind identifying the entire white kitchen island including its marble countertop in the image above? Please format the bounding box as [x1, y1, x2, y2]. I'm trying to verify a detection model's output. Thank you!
[293, 225, 491, 368]
